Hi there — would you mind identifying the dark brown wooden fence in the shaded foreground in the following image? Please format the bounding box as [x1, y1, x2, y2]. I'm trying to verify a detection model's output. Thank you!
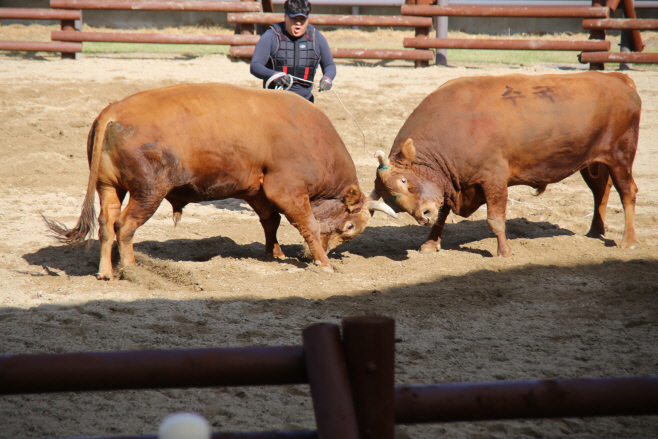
[0, 317, 658, 439]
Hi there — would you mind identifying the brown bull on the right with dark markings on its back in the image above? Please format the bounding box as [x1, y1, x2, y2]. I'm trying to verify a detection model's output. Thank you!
[373, 72, 641, 257]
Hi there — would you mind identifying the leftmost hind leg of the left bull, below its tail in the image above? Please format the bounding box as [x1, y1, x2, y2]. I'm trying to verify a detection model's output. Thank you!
[96, 185, 126, 280]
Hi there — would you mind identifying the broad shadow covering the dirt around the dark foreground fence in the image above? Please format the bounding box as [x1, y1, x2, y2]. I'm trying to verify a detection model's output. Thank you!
[0, 256, 658, 437]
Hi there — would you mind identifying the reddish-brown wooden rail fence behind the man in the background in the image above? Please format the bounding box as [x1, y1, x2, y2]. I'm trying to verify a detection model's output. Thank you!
[0, 0, 658, 70]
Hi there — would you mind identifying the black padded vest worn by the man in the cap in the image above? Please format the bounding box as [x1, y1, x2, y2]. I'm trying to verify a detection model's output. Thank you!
[266, 22, 320, 88]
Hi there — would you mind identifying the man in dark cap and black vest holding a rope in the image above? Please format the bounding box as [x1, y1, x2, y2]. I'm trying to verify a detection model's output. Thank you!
[250, 0, 336, 102]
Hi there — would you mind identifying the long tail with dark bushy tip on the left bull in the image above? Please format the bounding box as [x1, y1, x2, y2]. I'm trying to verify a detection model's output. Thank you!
[41, 113, 112, 247]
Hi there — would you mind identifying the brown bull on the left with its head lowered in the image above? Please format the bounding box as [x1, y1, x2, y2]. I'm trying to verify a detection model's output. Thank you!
[46, 84, 394, 279]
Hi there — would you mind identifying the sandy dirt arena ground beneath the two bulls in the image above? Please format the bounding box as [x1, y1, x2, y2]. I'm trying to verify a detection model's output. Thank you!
[0, 45, 658, 439]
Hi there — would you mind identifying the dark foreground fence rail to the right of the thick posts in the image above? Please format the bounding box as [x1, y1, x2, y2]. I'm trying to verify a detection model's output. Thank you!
[395, 376, 658, 424]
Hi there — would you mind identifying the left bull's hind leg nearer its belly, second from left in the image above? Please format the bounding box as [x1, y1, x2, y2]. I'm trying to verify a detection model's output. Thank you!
[115, 196, 164, 267]
